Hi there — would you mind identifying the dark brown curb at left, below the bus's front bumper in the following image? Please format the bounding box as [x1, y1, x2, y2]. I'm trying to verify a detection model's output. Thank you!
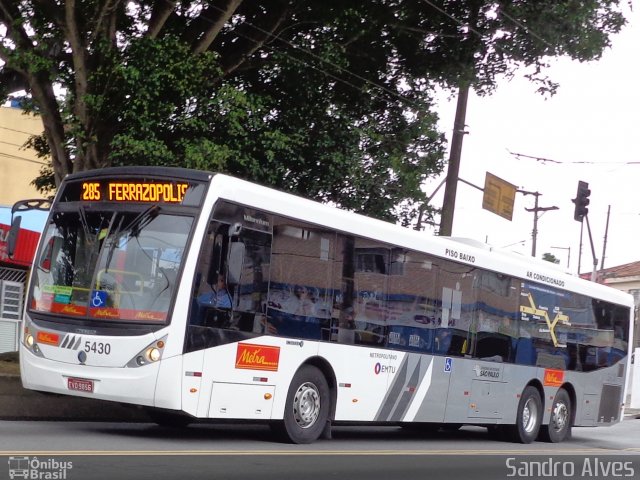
[0, 375, 150, 422]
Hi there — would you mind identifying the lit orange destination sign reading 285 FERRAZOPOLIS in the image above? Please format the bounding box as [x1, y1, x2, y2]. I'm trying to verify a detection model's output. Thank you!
[80, 181, 189, 203]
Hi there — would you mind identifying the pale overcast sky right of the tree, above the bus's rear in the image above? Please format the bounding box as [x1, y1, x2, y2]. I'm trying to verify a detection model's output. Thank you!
[426, 2, 640, 273]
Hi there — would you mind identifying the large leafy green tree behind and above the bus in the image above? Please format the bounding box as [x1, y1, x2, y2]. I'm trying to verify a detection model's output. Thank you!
[0, 0, 623, 224]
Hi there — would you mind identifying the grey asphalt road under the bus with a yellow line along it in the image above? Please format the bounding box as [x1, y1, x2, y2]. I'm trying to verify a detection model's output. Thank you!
[0, 419, 640, 480]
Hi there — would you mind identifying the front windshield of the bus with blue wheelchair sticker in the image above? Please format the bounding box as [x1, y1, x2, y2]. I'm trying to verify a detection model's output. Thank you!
[30, 205, 193, 323]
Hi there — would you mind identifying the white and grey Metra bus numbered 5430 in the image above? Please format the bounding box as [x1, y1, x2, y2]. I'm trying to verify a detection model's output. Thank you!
[20, 167, 633, 443]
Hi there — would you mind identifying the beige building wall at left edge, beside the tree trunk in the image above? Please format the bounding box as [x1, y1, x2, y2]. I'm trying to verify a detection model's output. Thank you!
[0, 107, 44, 205]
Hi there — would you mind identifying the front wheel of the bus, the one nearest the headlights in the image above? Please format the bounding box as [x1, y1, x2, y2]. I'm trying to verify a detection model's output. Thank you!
[274, 365, 331, 444]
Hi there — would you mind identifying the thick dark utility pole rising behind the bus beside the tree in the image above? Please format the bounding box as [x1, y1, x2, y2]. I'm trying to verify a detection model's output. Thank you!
[440, 84, 469, 236]
